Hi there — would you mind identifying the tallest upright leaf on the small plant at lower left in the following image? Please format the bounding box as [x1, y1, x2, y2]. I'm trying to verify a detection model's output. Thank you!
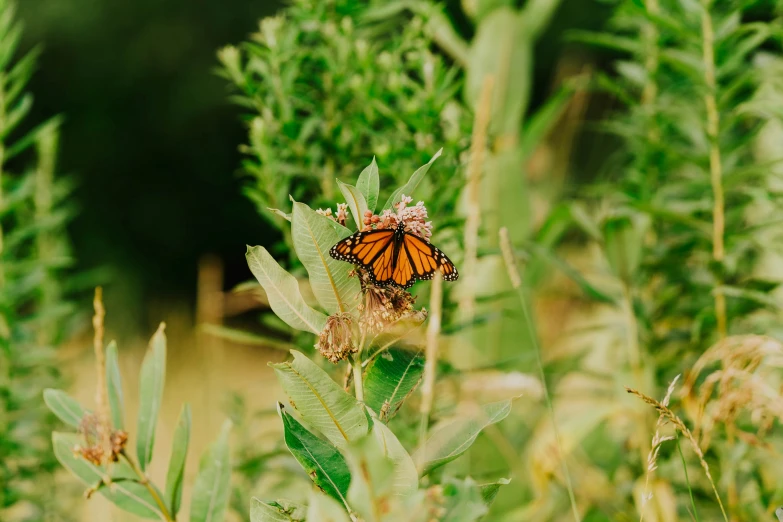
[136, 323, 166, 470]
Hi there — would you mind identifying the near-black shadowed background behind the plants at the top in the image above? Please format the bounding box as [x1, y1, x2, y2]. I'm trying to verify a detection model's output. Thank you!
[19, 0, 606, 327]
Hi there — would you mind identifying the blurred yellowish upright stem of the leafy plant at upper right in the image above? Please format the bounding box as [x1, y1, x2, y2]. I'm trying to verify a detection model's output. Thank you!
[701, 0, 727, 339]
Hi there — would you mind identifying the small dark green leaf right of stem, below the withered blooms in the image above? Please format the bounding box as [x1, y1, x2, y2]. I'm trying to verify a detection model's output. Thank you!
[364, 348, 424, 421]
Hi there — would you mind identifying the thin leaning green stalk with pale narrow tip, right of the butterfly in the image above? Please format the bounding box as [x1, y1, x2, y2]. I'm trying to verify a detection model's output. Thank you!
[499, 227, 581, 522]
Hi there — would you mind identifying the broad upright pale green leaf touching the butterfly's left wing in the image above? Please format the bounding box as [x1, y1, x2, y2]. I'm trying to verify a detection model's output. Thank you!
[291, 202, 361, 314]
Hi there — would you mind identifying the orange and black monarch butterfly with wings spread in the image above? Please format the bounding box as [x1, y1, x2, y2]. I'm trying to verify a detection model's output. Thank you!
[329, 223, 459, 288]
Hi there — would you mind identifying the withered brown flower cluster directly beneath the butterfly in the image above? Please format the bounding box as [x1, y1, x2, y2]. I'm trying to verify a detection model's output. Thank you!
[351, 267, 426, 333]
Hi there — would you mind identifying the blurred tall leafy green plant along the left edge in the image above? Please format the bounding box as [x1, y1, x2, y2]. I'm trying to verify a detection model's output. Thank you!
[0, 0, 76, 520]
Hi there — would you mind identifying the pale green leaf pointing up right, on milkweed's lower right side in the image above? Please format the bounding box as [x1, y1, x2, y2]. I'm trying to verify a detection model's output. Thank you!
[413, 400, 511, 476]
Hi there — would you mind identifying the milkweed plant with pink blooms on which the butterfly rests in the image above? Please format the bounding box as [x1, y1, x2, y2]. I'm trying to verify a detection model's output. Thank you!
[247, 153, 511, 522]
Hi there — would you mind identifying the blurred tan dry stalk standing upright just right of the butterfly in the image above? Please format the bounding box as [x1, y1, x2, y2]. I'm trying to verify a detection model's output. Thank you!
[459, 75, 495, 321]
